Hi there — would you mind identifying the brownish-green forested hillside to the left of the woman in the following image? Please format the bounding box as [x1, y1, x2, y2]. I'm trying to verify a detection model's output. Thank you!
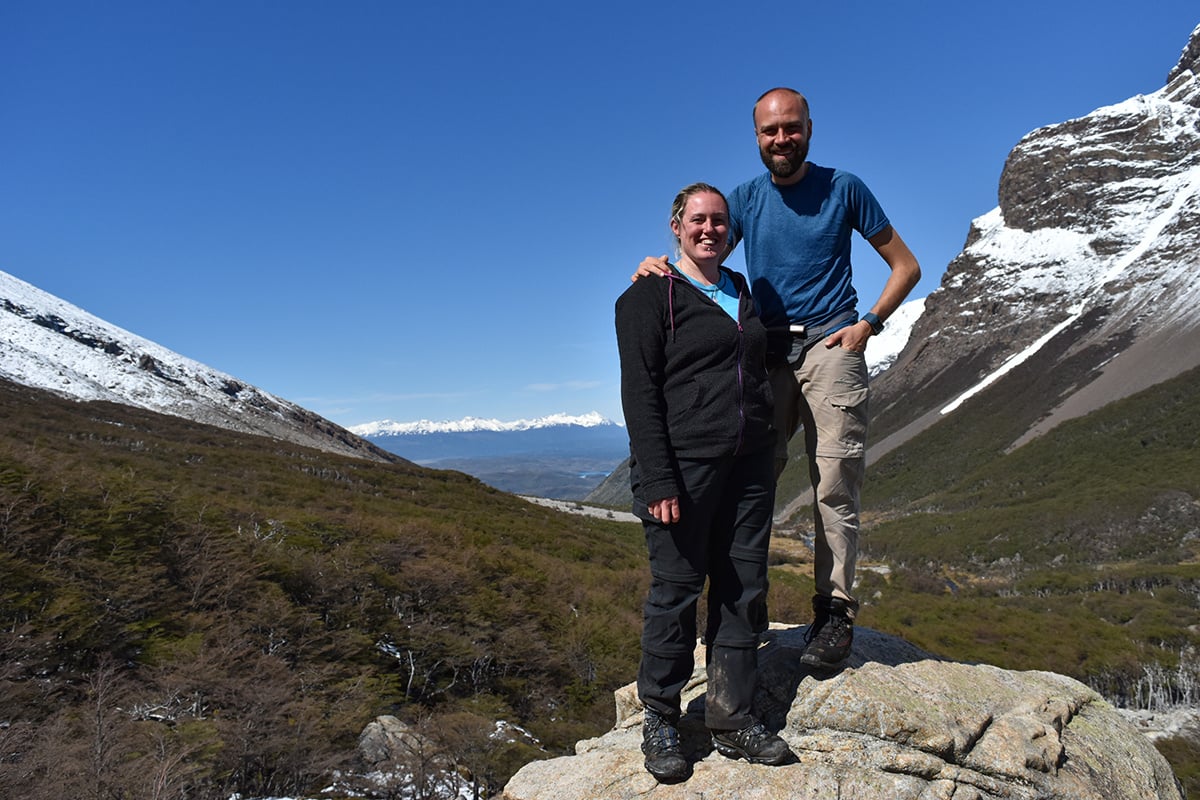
[0, 383, 667, 800]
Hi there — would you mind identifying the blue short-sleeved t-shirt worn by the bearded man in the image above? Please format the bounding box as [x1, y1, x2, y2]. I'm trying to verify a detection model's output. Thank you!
[728, 163, 890, 332]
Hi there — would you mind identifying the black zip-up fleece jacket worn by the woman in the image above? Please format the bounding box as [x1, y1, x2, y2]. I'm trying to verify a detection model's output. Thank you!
[617, 267, 775, 503]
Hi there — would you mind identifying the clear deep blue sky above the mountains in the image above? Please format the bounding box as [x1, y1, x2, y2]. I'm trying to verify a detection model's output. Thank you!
[7, 0, 1200, 426]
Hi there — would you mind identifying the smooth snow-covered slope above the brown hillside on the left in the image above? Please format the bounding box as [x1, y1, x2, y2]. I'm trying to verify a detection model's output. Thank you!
[0, 272, 392, 461]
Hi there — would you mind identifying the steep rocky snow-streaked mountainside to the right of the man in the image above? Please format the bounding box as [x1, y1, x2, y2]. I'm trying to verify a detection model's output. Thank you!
[872, 21, 1200, 457]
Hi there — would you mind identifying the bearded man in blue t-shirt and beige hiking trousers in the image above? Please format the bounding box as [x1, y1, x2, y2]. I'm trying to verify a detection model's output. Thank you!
[635, 88, 920, 670]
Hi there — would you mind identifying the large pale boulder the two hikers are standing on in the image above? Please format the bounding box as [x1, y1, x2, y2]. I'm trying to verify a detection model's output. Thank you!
[502, 627, 1184, 800]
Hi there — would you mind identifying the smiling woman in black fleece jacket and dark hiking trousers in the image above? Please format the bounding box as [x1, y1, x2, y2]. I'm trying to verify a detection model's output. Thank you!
[617, 184, 791, 782]
